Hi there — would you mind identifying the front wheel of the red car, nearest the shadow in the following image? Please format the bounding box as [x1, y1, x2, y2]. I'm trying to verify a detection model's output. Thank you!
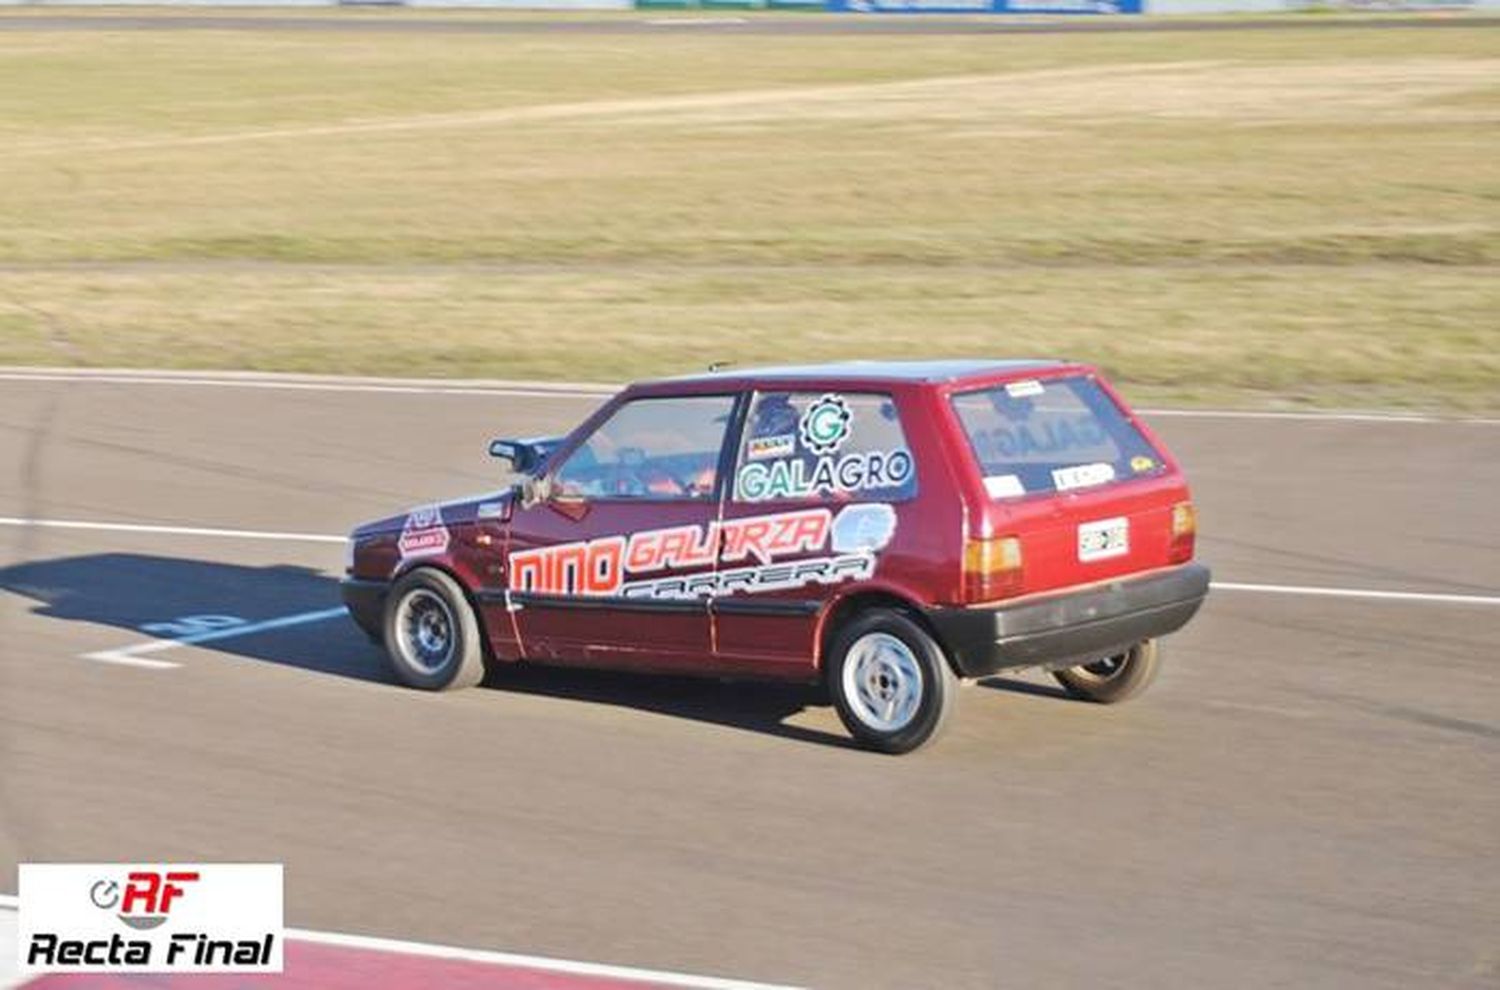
[383, 567, 485, 692]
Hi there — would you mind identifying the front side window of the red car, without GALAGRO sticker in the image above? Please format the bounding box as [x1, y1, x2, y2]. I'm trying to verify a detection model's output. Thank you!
[554, 396, 735, 500]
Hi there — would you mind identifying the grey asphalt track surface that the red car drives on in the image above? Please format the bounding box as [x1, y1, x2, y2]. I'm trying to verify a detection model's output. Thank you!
[0, 378, 1500, 989]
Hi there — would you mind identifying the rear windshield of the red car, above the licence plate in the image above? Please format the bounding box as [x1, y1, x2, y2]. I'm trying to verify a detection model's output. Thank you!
[953, 375, 1164, 498]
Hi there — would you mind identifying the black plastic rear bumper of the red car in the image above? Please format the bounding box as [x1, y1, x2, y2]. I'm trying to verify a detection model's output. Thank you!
[926, 564, 1209, 677]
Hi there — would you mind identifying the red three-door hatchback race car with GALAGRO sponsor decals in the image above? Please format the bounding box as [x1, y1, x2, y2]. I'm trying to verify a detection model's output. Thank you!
[342, 360, 1209, 753]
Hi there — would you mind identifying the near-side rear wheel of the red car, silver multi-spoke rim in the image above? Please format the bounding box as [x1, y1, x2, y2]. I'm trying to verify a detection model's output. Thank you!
[825, 609, 959, 753]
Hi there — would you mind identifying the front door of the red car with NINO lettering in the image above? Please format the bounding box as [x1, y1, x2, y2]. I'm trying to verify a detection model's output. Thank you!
[507, 395, 738, 669]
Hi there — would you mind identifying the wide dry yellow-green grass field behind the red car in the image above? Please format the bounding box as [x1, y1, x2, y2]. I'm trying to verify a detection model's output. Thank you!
[0, 15, 1500, 411]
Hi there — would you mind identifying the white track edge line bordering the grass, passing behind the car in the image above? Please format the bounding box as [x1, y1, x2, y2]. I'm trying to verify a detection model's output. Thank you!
[0, 366, 1500, 426]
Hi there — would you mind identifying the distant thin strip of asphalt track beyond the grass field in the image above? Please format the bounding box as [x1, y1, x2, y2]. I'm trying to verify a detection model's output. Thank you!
[0, 9, 1500, 36]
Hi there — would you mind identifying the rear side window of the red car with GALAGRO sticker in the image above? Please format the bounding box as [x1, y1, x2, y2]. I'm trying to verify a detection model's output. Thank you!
[734, 392, 917, 503]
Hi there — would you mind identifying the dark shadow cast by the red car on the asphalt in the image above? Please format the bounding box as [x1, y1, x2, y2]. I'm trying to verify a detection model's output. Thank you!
[0, 554, 851, 746]
